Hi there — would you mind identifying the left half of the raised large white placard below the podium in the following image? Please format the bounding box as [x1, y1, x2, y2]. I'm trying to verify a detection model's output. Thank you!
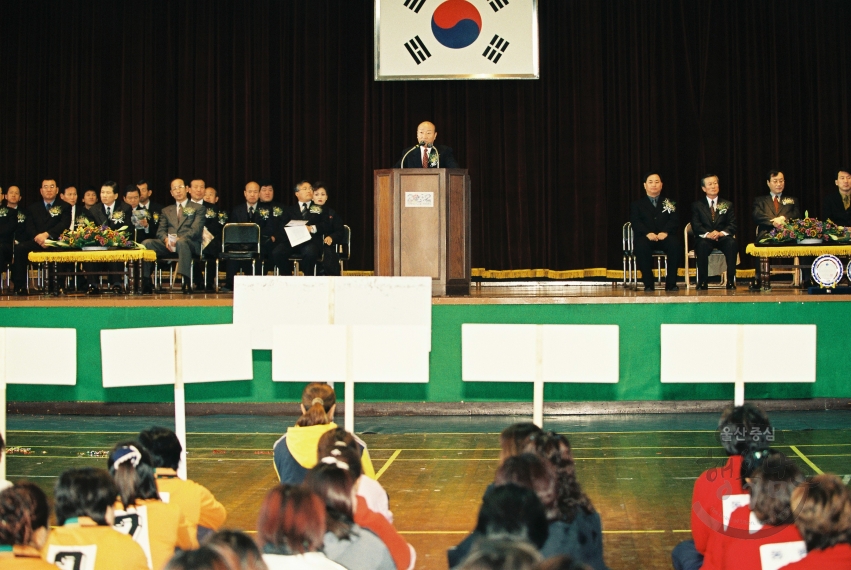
[233, 275, 332, 350]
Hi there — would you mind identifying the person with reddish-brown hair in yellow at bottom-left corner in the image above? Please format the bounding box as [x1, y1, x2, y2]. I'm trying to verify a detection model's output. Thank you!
[0, 484, 56, 570]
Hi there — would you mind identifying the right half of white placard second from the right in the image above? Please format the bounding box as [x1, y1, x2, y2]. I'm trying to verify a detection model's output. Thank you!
[541, 325, 620, 384]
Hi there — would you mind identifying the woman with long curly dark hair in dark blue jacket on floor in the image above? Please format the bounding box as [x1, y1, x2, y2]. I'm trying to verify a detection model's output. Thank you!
[524, 431, 606, 570]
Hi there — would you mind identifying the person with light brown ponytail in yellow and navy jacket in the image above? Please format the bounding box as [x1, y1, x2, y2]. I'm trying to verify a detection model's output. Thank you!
[272, 382, 375, 485]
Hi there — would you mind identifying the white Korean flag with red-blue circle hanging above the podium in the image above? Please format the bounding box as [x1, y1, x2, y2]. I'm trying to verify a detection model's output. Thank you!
[375, 0, 538, 80]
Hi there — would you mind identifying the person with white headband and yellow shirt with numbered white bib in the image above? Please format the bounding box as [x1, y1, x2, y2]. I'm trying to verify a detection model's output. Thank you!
[108, 441, 198, 569]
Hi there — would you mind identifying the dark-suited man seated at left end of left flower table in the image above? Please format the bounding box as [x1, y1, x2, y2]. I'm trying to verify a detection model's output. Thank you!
[12, 178, 71, 295]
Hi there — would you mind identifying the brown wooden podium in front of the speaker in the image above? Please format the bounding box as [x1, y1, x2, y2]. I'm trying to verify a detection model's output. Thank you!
[373, 168, 470, 296]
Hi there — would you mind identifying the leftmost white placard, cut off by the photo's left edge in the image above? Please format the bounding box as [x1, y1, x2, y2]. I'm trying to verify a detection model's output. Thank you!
[4, 328, 77, 386]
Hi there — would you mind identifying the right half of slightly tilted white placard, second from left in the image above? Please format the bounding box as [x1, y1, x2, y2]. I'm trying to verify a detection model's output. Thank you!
[176, 325, 254, 384]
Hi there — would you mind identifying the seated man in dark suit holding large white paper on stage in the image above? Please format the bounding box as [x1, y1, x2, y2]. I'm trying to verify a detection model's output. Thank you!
[263, 180, 324, 275]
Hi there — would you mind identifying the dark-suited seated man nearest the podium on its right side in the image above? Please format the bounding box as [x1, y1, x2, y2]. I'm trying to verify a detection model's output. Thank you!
[629, 172, 683, 291]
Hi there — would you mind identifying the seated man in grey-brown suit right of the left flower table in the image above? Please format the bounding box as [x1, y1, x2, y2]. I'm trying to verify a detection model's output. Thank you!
[142, 178, 206, 295]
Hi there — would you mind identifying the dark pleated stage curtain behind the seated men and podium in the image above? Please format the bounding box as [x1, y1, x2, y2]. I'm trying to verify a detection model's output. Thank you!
[0, 0, 851, 269]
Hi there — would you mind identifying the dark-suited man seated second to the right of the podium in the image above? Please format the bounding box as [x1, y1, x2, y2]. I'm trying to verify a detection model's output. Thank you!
[691, 174, 739, 290]
